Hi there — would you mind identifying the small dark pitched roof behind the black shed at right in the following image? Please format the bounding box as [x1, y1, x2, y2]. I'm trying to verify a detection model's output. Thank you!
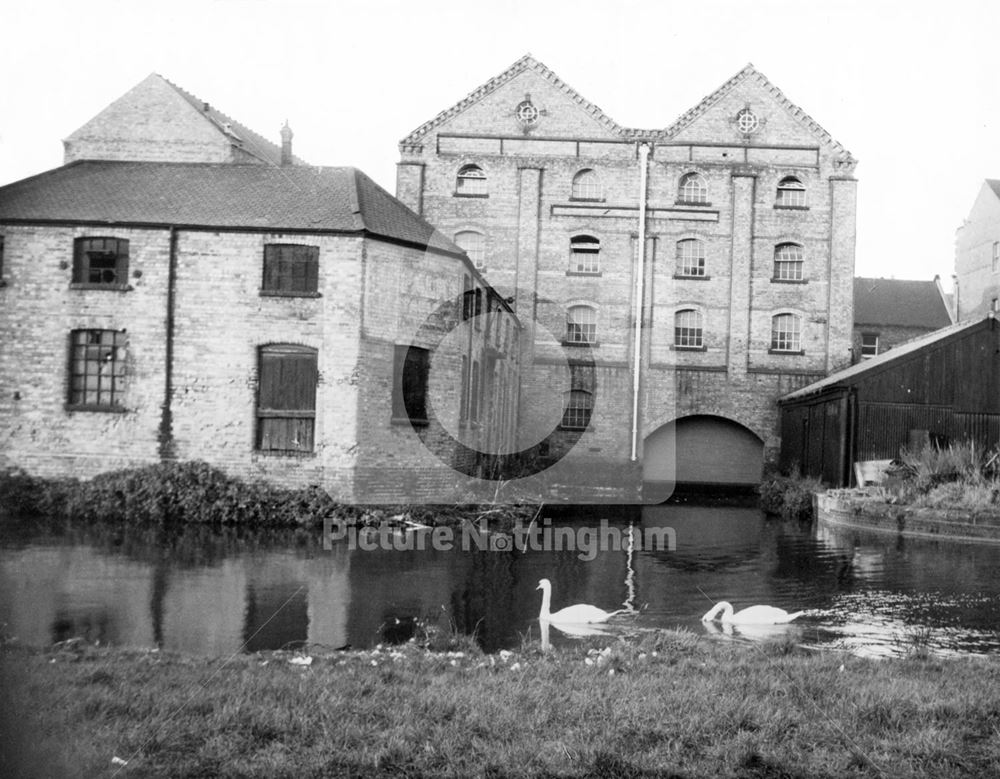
[854, 277, 951, 330]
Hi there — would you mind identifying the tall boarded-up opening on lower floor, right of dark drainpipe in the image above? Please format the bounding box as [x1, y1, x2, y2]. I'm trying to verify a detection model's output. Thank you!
[257, 344, 317, 452]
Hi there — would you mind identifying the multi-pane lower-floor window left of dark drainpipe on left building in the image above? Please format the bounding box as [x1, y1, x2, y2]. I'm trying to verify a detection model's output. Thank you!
[68, 330, 126, 411]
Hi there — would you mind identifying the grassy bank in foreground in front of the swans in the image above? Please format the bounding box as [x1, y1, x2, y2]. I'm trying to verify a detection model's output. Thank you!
[0, 632, 1000, 778]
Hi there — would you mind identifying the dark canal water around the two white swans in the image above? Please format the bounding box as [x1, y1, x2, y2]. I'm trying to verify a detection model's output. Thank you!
[0, 504, 1000, 656]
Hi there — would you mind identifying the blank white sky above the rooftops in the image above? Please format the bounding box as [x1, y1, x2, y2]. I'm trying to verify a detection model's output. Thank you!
[0, 0, 1000, 283]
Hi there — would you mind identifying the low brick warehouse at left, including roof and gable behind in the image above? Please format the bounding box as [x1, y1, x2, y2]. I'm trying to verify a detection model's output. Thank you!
[0, 76, 519, 501]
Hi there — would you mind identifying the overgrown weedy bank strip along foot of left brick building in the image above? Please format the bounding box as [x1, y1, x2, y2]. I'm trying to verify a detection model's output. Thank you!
[0, 462, 534, 528]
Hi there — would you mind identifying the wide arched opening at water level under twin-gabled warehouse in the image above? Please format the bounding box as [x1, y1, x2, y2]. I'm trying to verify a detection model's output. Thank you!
[642, 414, 764, 500]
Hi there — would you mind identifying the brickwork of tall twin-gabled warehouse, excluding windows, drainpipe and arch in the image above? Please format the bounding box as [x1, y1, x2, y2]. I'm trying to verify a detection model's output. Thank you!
[398, 62, 855, 494]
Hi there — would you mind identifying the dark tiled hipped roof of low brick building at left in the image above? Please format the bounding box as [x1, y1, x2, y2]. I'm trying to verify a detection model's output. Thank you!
[0, 160, 462, 255]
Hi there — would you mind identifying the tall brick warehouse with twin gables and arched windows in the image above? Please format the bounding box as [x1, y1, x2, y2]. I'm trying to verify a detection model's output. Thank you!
[396, 56, 856, 496]
